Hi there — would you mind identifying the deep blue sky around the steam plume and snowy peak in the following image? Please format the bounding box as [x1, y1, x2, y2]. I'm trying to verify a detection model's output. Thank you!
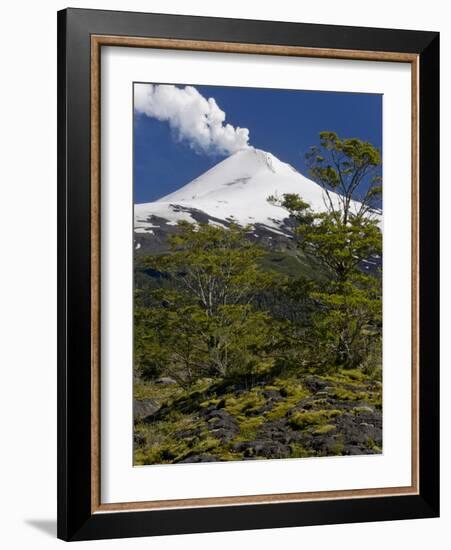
[133, 84, 382, 203]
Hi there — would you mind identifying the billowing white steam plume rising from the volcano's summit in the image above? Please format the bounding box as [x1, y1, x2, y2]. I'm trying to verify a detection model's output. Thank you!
[134, 84, 254, 155]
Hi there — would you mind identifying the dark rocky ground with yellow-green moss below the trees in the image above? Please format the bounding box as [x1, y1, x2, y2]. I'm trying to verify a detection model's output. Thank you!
[134, 370, 382, 465]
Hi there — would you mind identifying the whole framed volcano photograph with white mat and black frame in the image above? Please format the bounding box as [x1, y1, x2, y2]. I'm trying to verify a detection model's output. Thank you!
[58, 9, 439, 540]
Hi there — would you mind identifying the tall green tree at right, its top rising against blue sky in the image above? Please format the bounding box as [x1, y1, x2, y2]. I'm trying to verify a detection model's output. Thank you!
[268, 132, 382, 376]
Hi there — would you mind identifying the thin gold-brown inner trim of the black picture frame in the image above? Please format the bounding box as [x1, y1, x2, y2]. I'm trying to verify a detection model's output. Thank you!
[91, 35, 420, 513]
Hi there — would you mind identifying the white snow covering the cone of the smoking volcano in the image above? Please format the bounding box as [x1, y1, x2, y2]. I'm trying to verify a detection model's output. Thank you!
[135, 147, 368, 234]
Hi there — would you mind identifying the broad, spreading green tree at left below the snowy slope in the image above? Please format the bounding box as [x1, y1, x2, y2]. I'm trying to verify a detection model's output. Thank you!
[135, 222, 276, 387]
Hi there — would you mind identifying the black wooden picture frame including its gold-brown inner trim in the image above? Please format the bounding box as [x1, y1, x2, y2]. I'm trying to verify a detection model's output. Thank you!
[58, 9, 439, 540]
